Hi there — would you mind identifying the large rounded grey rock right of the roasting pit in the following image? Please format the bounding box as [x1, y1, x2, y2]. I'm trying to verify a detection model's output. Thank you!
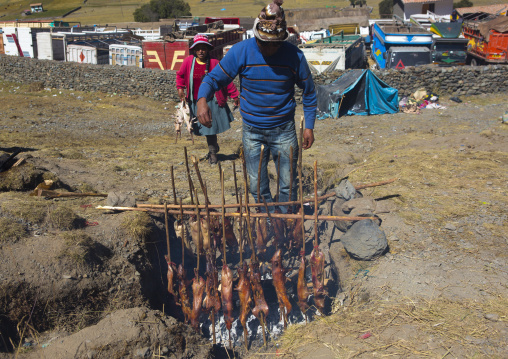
[340, 219, 388, 261]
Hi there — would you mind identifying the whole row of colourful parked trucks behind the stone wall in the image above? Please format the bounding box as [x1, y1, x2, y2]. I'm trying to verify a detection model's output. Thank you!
[0, 14, 508, 74]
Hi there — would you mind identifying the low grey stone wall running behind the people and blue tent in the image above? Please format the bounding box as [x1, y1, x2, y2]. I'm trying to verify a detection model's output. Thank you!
[0, 55, 508, 102]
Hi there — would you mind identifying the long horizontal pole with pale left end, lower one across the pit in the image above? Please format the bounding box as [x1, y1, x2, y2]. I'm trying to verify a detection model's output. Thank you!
[95, 203, 378, 221]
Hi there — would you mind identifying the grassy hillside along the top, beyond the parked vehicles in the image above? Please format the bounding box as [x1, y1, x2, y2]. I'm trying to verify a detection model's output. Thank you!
[0, 0, 504, 24]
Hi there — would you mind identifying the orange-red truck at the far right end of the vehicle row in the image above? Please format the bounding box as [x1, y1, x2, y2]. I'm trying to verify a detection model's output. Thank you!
[462, 16, 508, 66]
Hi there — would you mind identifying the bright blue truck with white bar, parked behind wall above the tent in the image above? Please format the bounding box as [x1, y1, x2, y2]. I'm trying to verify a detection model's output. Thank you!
[371, 20, 433, 69]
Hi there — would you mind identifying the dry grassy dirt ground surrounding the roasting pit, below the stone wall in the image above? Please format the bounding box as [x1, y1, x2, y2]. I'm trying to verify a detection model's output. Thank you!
[0, 82, 508, 359]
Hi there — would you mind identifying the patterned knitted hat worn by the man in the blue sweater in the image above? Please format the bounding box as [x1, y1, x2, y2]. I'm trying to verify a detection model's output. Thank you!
[252, 0, 289, 41]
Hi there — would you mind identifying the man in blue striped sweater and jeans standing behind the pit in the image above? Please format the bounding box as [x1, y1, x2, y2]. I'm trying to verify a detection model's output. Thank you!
[197, 0, 317, 210]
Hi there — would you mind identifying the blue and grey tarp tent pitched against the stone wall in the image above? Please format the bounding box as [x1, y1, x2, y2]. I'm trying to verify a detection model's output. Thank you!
[317, 70, 399, 120]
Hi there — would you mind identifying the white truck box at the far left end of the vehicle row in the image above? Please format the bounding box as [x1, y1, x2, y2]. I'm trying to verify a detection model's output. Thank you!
[2, 27, 49, 58]
